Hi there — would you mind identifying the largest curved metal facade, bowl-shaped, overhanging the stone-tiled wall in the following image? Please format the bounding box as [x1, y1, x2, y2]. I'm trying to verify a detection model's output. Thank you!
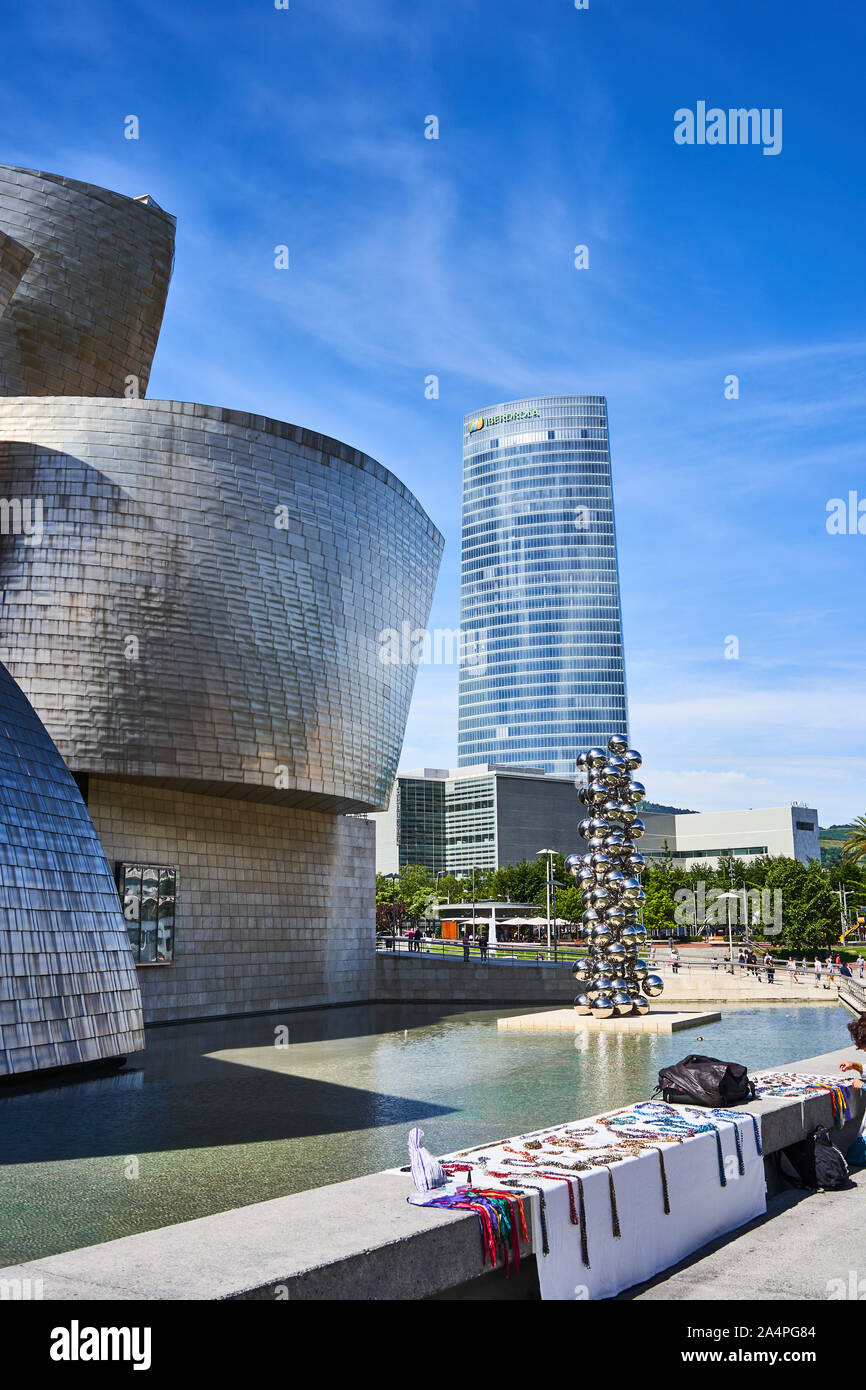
[0, 399, 442, 810]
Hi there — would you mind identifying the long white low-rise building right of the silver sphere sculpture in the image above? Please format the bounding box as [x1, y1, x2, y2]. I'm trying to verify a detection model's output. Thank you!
[639, 806, 822, 869]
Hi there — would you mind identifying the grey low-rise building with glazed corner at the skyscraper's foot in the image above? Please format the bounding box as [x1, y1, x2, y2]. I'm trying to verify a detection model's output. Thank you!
[371, 763, 581, 876]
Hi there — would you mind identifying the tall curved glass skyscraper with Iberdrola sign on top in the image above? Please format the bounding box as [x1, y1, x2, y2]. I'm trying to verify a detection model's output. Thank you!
[457, 396, 628, 777]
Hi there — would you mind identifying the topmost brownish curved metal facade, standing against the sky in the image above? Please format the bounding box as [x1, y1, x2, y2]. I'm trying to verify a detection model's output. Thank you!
[0, 164, 175, 396]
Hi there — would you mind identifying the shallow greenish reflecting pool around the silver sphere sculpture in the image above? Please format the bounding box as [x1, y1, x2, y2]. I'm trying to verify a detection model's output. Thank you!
[0, 1004, 849, 1265]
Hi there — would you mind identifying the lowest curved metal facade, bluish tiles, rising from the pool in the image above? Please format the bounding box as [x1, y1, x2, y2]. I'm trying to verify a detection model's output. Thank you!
[0, 666, 145, 1076]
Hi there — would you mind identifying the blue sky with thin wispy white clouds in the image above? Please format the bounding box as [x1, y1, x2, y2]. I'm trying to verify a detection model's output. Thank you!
[0, 0, 866, 824]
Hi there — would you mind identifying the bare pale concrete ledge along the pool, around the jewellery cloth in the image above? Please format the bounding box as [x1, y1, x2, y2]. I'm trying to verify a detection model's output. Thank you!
[0, 1048, 865, 1301]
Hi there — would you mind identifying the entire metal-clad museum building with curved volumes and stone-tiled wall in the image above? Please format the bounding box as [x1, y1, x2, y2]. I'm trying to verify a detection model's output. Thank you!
[0, 167, 442, 1076]
